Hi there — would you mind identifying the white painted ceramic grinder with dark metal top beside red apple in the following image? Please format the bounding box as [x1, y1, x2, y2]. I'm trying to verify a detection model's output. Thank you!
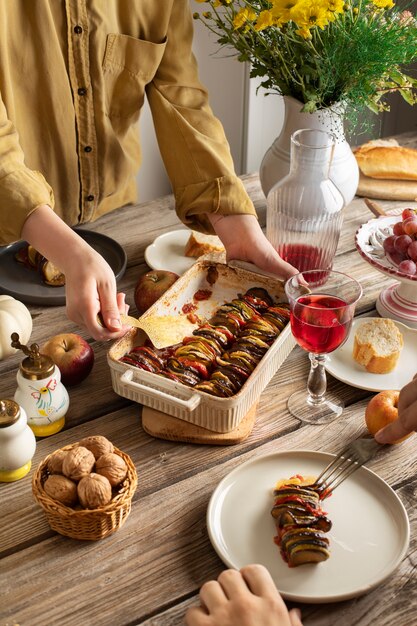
[11, 333, 69, 437]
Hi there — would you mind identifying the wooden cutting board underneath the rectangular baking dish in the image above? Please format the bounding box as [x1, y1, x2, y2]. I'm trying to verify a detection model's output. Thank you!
[142, 403, 258, 446]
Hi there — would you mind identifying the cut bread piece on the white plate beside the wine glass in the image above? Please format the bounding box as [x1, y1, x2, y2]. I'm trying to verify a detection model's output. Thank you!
[353, 317, 404, 374]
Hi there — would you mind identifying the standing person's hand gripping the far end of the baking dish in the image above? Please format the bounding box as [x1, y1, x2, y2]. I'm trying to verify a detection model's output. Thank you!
[208, 213, 298, 280]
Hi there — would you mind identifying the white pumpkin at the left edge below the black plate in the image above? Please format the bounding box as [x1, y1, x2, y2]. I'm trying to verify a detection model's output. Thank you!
[0, 296, 32, 361]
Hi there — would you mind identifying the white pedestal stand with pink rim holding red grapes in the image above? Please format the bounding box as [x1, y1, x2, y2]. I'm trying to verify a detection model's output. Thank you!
[355, 215, 417, 328]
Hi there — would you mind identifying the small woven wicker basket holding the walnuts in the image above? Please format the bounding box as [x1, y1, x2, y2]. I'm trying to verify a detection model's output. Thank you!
[32, 443, 137, 541]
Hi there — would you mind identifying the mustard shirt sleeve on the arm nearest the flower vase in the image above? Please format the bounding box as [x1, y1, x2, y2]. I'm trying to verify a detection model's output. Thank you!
[147, 0, 256, 232]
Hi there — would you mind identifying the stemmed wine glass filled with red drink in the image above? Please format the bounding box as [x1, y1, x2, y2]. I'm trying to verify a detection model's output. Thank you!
[285, 269, 362, 424]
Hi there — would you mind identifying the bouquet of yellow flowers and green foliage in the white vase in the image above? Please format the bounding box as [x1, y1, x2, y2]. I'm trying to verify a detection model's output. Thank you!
[194, 0, 417, 123]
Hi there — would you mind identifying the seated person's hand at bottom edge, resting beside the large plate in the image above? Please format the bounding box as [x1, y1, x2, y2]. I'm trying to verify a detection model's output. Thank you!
[185, 565, 302, 626]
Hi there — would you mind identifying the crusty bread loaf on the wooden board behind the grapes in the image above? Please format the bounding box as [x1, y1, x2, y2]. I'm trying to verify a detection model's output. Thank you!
[354, 140, 417, 180]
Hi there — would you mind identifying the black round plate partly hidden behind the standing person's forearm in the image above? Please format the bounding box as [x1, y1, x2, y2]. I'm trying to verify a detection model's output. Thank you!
[0, 228, 127, 306]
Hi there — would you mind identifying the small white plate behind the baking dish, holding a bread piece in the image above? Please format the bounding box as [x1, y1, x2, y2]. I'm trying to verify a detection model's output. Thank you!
[145, 229, 196, 275]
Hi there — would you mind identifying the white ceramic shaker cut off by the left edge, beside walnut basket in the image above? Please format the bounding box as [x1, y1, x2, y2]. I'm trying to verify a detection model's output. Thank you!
[0, 400, 36, 483]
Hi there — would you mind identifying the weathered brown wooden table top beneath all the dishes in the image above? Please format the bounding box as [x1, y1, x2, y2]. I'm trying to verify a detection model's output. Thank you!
[0, 136, 417, 626]
